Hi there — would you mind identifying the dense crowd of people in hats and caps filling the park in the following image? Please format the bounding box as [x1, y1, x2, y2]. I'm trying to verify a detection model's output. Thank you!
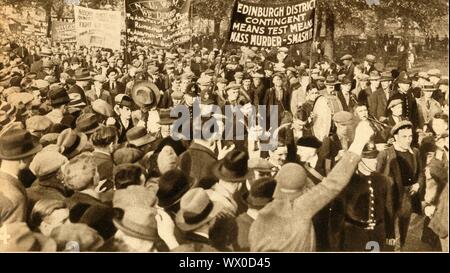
[0, 32, 448, 252]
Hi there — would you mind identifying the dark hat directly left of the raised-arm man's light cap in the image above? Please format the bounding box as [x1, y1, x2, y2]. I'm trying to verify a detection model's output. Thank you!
[244, 177, 277, 209]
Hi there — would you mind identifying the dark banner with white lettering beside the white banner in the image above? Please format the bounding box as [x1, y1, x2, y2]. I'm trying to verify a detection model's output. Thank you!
[125, 0, 192, 48]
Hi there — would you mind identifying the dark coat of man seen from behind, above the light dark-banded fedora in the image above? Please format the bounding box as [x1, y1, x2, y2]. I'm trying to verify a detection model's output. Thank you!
[179, 143, 217, 188]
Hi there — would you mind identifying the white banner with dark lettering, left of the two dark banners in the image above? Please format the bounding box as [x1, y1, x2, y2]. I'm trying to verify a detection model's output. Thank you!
[75, 6, 121, 50]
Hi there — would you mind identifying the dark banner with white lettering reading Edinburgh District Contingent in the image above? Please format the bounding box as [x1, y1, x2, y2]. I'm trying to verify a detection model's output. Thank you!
[228, 0, 316, 47]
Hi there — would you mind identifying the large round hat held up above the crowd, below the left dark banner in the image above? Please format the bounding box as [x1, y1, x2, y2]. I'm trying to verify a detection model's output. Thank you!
[131, 81, 161, 108]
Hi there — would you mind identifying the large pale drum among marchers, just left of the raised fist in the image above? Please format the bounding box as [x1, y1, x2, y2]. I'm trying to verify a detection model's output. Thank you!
[312, 95, 344, 141]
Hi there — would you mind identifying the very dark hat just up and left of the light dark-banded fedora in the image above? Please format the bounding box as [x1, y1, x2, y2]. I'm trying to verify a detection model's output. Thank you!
[156, 169, 193, 208]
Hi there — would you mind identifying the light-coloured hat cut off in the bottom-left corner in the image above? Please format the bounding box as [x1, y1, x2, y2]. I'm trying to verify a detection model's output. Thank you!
[0, 222, 57, 252]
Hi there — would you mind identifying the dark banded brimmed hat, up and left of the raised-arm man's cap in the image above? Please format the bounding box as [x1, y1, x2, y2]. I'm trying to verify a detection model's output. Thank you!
[213, 149, 249, 182]
